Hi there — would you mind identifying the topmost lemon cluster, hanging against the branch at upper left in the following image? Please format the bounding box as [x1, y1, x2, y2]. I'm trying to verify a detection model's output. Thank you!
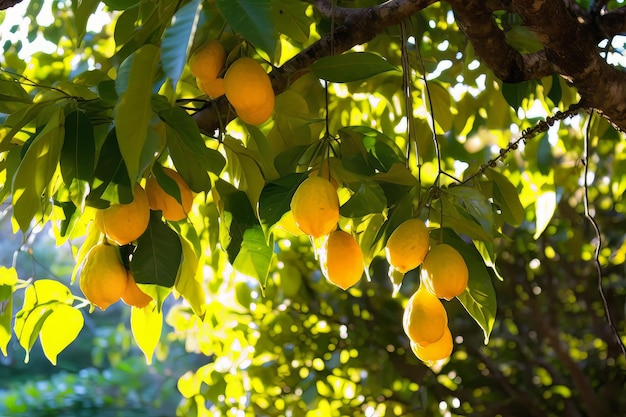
[189, 39, 275, 125]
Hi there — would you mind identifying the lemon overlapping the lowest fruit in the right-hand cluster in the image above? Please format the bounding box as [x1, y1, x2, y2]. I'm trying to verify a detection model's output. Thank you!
[402, 285, 448, 347]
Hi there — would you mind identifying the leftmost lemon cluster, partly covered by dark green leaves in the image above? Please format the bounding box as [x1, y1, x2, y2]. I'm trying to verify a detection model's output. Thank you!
[79, 167, 193, 310]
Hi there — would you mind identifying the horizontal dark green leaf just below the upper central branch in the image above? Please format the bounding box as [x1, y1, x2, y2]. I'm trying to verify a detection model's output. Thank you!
[311, 52, 397, 83]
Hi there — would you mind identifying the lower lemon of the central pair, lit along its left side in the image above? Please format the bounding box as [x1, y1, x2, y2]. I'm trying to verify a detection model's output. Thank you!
[320, 230, 363, 290]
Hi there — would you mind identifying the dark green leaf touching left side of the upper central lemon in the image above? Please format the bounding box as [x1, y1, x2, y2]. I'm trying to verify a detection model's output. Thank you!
[259, 172, 309, 239]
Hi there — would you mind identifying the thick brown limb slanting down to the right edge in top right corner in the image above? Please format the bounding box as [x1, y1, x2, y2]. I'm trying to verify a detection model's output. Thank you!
[513, 0, 626, 130]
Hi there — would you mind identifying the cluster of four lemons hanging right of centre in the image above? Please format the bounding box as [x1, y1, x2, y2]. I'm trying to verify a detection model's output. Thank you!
[385, 219, 469, 363]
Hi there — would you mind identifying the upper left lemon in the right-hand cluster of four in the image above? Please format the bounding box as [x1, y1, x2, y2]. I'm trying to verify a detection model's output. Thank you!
[385, 219, 430, 273]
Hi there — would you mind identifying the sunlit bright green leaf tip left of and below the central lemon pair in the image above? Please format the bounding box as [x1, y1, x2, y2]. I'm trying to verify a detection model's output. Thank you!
[233, 226, 272, 286]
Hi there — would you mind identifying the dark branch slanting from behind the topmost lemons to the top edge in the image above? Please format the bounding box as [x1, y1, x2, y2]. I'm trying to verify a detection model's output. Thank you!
[194, 0, 438, 134]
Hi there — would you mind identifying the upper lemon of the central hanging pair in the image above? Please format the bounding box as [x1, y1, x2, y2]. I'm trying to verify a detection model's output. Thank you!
[291, 177, 339, 238]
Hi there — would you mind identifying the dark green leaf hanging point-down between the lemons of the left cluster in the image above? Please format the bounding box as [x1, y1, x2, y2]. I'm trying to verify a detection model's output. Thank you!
[130, 211, 183, 290]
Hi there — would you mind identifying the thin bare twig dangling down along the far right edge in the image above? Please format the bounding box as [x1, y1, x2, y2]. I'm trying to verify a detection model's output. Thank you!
[582, 111, 626, 356]
